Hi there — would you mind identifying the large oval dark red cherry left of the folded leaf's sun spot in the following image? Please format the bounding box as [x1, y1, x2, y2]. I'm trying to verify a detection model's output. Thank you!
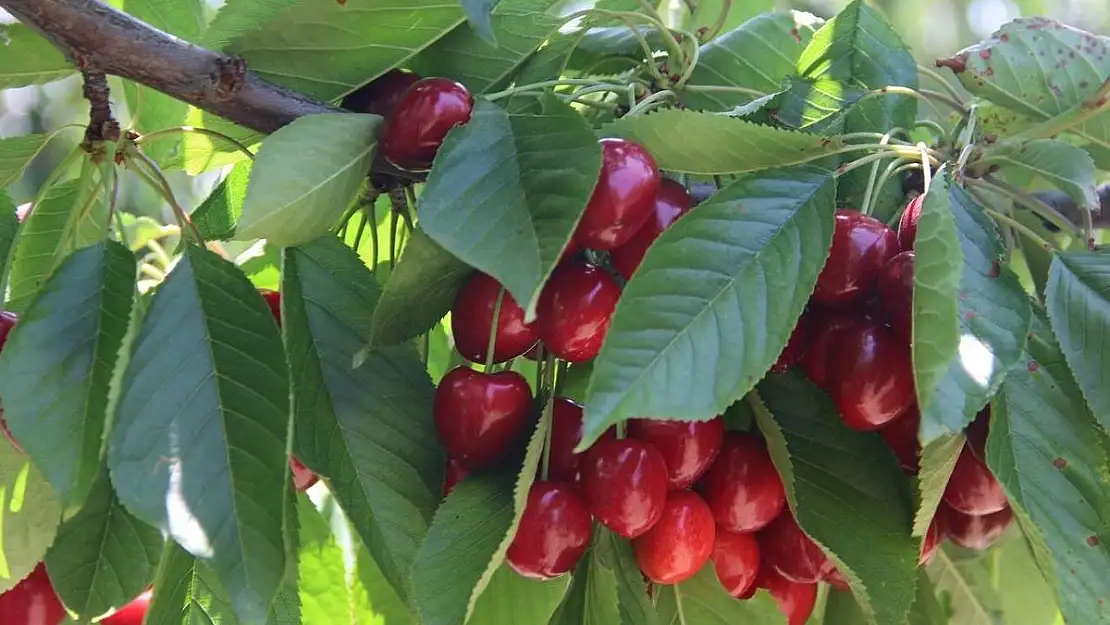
[828, 322, 917, 431]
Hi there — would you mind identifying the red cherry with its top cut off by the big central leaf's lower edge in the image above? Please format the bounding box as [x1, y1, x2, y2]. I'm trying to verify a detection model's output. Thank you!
[628, 416, 725, 491]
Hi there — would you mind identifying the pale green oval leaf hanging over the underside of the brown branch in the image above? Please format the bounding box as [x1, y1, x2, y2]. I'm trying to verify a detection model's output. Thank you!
[235, 113, 382, 246]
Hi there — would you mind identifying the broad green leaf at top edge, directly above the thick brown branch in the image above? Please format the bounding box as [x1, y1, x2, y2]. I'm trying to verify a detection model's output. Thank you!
[223, 0, 466, 100]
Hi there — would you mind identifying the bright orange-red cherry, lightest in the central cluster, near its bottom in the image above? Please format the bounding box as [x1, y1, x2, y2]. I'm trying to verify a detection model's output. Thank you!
[632, 491, 717, 584]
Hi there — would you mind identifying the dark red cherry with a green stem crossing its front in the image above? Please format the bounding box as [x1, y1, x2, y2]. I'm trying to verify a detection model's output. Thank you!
[451, 272, 539, 363]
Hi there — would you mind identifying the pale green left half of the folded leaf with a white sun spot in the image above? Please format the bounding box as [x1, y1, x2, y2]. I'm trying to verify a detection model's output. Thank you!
[911, 168, 963, 417]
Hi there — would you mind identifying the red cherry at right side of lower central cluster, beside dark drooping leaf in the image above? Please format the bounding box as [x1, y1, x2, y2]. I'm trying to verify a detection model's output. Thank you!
[700, 432, 786, 533]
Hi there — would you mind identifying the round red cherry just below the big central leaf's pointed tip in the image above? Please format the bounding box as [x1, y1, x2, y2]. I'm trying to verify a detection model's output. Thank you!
[578, 438, 667, 538]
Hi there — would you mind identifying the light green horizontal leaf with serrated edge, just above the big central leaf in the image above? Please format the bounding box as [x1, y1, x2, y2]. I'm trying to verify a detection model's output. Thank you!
[603, 109, 841, 175]
